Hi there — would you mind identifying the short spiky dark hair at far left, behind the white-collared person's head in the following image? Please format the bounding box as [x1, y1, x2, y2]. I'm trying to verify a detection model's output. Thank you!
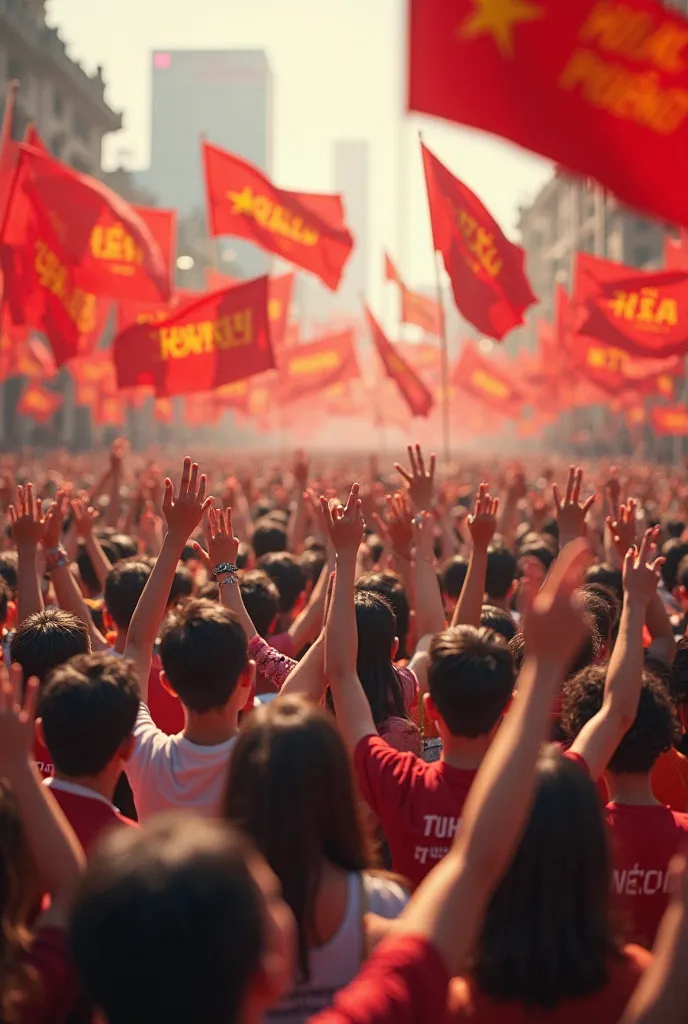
[9, 608, 91, 684]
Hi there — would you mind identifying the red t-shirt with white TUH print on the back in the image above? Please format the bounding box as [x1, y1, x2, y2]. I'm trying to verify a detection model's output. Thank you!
[353, 735, 476, 885]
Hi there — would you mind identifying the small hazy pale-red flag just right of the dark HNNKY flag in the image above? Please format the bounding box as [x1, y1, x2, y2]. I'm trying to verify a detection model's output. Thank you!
[278, 331, 360, 403]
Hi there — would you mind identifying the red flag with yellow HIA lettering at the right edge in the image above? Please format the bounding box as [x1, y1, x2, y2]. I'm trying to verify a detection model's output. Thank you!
[572, 249, 688, 358]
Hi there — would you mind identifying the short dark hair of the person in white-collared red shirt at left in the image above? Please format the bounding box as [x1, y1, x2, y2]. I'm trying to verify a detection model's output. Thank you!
[40, 653, 139, 778]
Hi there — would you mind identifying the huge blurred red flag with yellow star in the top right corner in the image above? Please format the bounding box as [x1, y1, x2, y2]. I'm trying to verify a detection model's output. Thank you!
[409, 0, 688, 231]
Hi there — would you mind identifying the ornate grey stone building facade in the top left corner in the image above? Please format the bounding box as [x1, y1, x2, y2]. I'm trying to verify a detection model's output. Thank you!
[0, 0, 122, 174]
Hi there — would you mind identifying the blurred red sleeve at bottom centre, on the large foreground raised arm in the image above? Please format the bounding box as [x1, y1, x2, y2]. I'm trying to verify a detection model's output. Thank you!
[309, 936, 449, 1024]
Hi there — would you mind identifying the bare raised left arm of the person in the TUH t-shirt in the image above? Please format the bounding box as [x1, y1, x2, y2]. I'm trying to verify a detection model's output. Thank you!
[320, 483, 377, 750]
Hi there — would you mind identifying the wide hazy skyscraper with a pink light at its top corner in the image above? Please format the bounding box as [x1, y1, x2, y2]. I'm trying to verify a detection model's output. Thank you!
[141, 50, 272, 276]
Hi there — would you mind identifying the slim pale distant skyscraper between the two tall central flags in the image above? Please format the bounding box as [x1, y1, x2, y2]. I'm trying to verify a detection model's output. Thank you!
[334, 139, 371, 312]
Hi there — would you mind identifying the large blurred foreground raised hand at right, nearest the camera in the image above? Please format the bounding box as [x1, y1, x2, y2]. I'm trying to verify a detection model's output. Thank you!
[521, 538, 590, 667]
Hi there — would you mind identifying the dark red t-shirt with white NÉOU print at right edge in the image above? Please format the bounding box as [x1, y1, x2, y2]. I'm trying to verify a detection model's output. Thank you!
[606, 802, 688, 948]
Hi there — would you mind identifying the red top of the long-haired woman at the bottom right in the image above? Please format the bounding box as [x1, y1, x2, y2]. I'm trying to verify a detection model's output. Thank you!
[445, 946, 652, 1024]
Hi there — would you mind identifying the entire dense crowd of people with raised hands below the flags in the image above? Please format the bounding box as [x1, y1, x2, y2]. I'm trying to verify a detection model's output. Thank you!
[0, 441, 688, 1024]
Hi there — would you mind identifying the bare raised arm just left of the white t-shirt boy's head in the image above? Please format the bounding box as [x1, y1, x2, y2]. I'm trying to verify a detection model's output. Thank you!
[124, 457, 213, 703]
